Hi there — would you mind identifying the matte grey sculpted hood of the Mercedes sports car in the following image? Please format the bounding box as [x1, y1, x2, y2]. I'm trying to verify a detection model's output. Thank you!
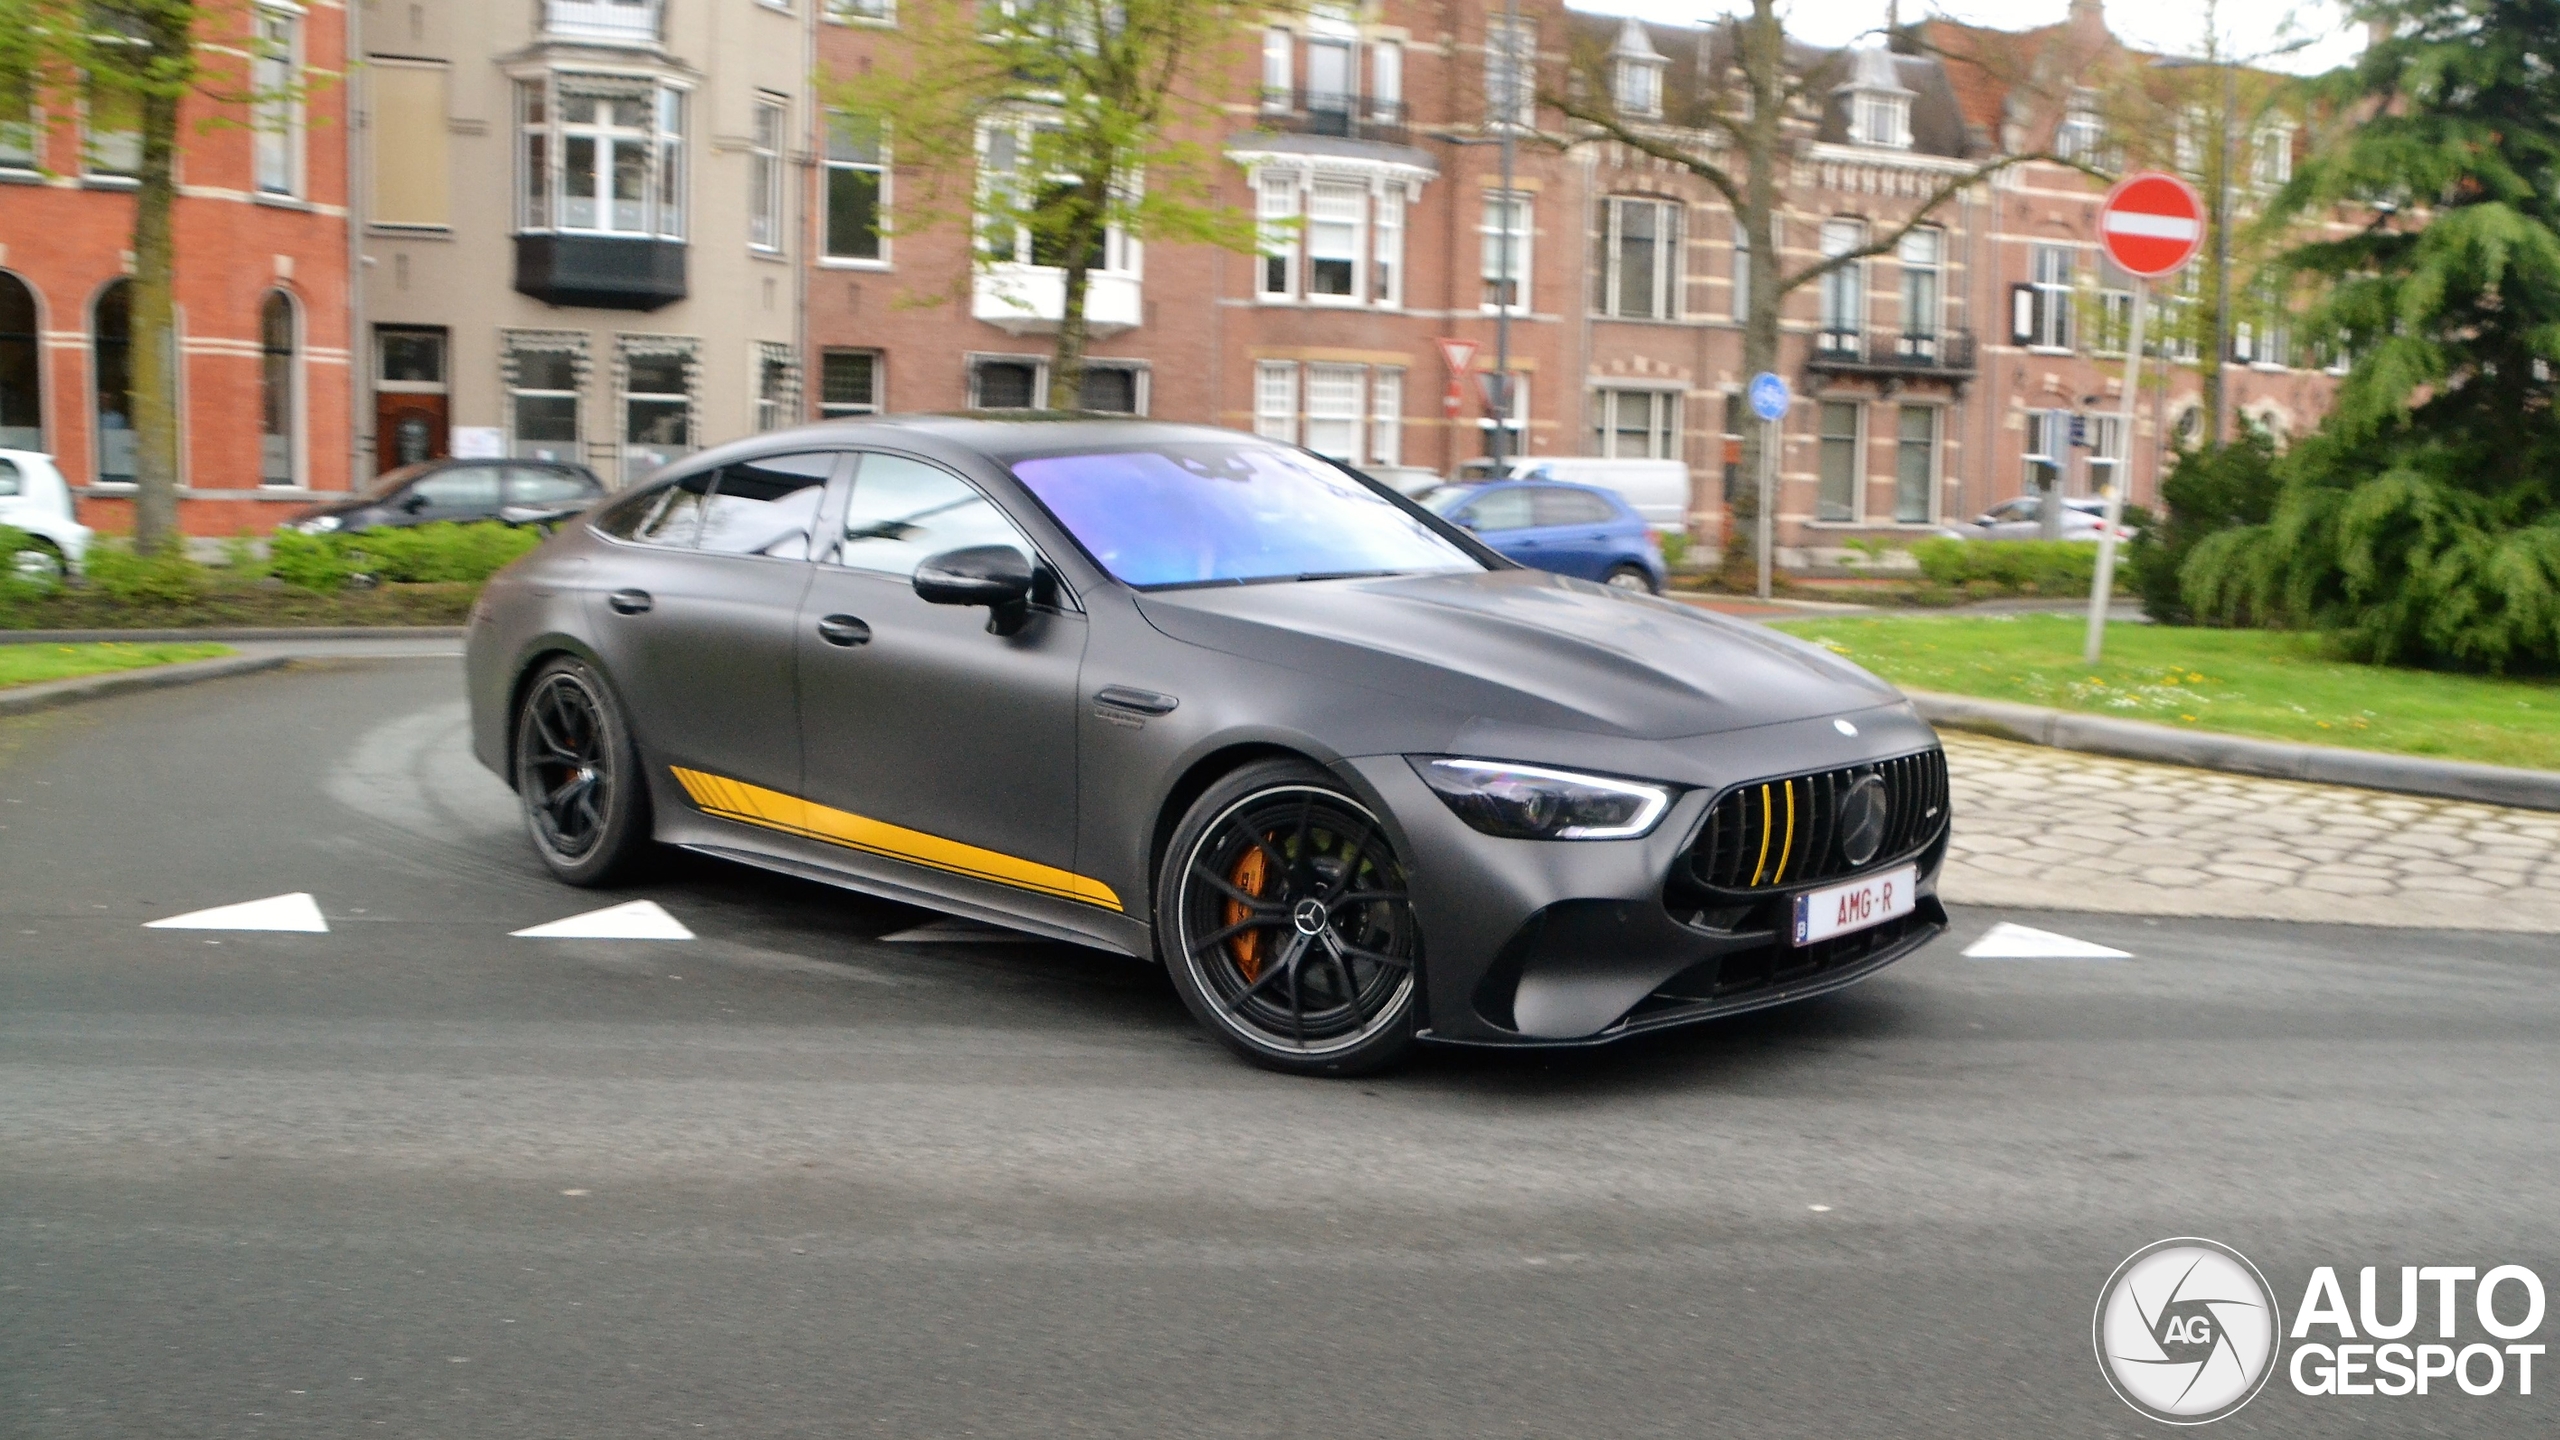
[1137, 569, 1900, 740]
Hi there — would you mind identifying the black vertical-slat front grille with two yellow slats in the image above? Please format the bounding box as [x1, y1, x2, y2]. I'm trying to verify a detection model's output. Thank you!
[1690, 751, 1946, 892]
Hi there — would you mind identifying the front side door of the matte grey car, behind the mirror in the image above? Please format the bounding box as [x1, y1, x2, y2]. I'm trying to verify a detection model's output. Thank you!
[799, 451, 1085, 894]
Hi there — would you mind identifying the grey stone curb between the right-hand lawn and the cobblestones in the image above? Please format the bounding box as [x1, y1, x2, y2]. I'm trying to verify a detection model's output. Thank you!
[1905, 689, 2560, 810]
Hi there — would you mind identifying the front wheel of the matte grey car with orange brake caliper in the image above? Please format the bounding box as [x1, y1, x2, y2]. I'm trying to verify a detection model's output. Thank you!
[1155, 761, 1423, 1076]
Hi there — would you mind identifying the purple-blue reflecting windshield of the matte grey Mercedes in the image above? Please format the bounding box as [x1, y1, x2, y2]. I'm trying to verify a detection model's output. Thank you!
[1014, 441, 1485, 589]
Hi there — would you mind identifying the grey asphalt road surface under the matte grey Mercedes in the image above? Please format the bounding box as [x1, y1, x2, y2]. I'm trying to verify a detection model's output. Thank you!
[0, 659, 2560, 1437]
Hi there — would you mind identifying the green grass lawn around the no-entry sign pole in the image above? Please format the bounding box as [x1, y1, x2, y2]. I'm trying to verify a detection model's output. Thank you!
[1779, 615, 2560, 769]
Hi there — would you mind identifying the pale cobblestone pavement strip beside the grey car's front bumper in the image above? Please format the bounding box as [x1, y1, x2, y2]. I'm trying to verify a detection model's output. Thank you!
[1940, 733, 2560, 933]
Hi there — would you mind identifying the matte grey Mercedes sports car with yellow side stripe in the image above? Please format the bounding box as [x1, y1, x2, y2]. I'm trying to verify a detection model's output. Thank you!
[468, 418, 1948, 1074]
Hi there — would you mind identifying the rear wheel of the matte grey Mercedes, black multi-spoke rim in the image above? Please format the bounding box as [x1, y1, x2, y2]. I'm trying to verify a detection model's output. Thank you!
[515, 656, 650, 887]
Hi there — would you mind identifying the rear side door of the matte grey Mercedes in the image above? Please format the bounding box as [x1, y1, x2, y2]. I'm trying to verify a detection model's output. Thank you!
[589, 451, 840, 792]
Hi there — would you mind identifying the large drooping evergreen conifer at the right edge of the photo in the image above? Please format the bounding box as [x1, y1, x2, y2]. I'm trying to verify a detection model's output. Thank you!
[2179, 0, 2560, 671]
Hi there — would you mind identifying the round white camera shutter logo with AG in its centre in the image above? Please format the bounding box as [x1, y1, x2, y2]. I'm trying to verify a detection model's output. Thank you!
[2092, 1238, 2284, 1425]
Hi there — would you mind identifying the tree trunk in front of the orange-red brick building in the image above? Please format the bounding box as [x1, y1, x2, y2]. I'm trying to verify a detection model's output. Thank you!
[131, 87, 182, 553]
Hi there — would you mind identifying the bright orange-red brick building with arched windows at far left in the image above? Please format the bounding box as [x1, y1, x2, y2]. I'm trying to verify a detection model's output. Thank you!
[0, 3, 353, 536]
